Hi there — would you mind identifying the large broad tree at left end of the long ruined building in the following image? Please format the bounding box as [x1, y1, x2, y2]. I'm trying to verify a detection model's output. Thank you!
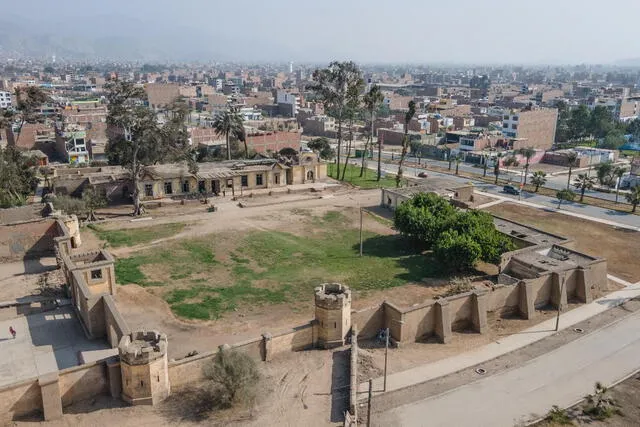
[105, 80, 193, 215]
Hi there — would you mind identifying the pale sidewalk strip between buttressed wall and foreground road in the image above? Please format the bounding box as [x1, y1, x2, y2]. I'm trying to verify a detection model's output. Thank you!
[358, 278, 640, 400]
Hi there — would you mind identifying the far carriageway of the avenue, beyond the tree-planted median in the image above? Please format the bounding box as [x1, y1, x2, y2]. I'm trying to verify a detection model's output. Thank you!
[374, 151, 628, 205]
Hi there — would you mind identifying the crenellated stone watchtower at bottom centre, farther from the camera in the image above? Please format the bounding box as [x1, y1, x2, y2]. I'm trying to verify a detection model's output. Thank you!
[315, 283, 351, 348]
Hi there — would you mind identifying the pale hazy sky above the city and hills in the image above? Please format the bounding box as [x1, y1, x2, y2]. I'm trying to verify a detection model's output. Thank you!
[7, 0, 640, 63]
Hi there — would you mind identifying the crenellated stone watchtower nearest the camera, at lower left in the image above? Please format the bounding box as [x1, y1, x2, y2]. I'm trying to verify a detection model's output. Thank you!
[118, 331, 170, 405]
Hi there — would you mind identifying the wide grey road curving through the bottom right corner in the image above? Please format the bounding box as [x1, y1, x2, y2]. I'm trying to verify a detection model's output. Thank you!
[372, 313, 640, 427]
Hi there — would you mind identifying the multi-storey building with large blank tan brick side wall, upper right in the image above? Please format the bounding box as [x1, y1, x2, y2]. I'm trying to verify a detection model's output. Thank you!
[502, 107, 558, 150]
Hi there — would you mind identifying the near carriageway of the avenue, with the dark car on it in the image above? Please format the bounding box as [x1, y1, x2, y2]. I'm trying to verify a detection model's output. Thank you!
[368, 162, 640, 231]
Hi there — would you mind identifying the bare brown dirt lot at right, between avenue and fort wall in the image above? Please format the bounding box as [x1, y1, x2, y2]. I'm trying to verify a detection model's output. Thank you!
[486, 203, 640, 283]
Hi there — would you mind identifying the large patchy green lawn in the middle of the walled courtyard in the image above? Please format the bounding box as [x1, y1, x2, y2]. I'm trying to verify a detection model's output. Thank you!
[116, 212, 438, 319]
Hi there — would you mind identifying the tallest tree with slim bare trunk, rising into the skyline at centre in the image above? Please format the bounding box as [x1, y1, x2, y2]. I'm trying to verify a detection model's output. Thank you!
[310, 61, 364, 181]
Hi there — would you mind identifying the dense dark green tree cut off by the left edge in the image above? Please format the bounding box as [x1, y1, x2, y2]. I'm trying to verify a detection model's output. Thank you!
[0, 147, 38, 208]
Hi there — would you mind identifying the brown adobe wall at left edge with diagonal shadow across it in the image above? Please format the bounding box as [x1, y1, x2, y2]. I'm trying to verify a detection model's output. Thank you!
[0, 218, 58, 262]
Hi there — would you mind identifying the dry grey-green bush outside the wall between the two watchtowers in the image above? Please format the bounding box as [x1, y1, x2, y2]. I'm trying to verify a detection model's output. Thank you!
[203, 350, 260, 408]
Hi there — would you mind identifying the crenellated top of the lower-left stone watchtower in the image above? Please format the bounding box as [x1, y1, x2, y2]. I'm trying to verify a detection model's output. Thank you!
[118, 331, 167, 365]
